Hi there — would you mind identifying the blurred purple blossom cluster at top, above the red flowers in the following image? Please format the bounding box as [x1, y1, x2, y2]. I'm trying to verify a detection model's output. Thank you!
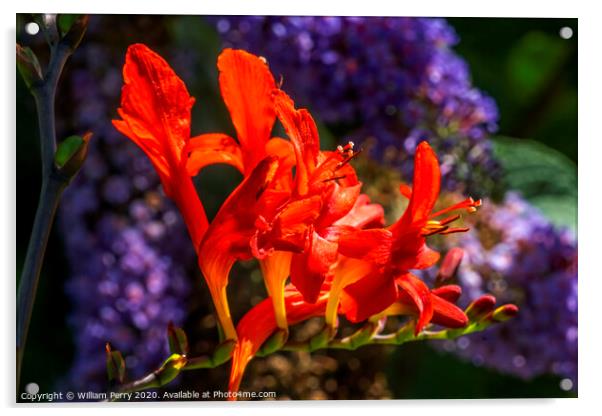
[211, 16, 499, 195]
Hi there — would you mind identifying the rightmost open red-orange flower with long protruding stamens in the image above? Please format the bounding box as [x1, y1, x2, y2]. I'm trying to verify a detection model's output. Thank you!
[326, 142, 481, 333]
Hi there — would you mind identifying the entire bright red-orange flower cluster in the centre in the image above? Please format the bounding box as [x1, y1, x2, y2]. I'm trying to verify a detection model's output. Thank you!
[114, 44, 502, 398]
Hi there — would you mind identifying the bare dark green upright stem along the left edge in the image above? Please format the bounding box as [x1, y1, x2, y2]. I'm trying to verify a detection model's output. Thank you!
[17, 43, 72, 389]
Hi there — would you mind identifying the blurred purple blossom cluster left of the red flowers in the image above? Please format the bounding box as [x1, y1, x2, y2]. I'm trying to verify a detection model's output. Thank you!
[59, 16, 195, 391]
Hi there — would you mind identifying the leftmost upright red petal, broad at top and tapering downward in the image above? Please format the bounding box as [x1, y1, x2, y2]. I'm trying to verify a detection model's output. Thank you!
[113, 44, 208, 247]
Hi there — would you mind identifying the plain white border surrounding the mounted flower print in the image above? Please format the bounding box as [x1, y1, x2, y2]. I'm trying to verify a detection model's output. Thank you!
[0, 0, 602, 416]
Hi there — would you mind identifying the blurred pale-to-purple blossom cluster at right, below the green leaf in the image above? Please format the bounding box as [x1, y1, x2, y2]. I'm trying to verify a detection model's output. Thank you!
[440, 193, 577, 390]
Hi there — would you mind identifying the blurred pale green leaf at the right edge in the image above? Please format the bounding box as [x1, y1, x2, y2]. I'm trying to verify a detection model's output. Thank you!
[493, 137, 577, 230]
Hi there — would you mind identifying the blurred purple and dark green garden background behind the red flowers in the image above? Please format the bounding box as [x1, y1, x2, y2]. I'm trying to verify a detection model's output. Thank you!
[16, 14, 578, 399]
